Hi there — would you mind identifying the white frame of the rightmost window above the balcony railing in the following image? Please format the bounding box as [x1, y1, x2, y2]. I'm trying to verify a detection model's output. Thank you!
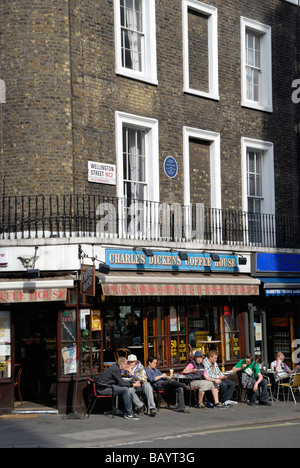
[242, 137, 275, 215]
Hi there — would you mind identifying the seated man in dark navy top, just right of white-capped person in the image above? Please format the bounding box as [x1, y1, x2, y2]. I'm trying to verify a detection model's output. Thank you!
[146, 356, 189, 413]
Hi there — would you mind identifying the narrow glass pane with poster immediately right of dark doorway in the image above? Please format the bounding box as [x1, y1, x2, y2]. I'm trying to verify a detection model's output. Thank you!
[61, 309, 77, 375]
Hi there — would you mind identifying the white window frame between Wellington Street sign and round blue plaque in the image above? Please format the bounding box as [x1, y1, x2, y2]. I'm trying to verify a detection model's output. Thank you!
[116, 112, 159, 202]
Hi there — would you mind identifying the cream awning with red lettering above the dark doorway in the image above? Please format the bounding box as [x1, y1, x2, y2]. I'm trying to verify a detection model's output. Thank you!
[0, 275, 74, 304]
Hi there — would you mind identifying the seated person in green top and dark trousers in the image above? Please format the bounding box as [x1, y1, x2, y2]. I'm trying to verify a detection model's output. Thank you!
[232, 354, 272, 406]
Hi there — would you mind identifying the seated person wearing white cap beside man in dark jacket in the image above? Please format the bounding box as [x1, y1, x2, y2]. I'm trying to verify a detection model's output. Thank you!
[124, 354, 156, 417]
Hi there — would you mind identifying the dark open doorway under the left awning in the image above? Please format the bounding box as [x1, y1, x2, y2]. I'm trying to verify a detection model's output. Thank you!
[14, 304, 58, 410]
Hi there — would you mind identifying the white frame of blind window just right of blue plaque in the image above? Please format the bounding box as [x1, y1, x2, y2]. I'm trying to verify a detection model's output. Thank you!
[183, 127, 222, 209]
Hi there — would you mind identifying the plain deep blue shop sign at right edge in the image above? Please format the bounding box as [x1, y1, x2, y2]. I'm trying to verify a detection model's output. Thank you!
[256, 253, 300, 273]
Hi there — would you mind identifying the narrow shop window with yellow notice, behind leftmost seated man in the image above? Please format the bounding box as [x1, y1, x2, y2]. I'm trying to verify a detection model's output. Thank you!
[80, 309, 103, 375]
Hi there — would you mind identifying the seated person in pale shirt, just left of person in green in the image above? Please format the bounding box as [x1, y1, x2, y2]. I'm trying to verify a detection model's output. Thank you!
[203, 351, 235, 408]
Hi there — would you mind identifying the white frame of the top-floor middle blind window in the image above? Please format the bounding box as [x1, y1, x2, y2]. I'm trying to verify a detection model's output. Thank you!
[182, 0, 220, 101]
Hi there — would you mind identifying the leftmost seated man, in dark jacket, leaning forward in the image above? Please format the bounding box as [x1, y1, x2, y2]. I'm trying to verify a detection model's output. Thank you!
[96, 357, 141, 420]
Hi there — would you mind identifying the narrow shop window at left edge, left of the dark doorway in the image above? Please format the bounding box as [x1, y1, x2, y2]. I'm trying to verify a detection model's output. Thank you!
[0, 311, 11, 379]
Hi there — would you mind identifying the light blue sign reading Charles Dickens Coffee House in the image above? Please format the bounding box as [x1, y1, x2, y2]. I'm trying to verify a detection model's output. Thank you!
[105, 249, 239, 273]
